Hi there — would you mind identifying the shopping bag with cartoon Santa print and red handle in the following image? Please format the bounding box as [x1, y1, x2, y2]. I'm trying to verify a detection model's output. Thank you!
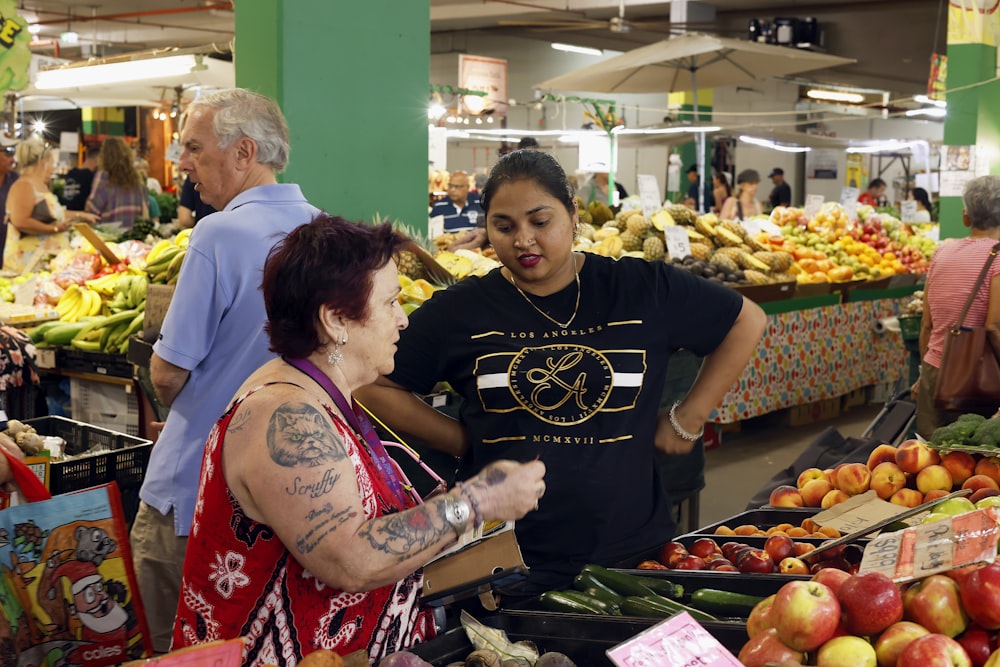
[0, 448, 153, 667]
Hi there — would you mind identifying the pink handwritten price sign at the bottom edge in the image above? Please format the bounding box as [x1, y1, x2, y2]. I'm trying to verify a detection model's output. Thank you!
[606, 612, 740, 667]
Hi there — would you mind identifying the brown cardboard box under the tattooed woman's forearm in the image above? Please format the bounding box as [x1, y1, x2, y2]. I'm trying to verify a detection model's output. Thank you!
[424, 530, 527, 599]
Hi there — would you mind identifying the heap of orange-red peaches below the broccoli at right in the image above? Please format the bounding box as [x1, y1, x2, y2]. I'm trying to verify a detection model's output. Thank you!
[769, 439, 1000, 509]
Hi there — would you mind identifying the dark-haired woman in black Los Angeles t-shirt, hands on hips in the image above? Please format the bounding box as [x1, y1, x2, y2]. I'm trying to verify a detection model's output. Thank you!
[357, 151, 766, 594]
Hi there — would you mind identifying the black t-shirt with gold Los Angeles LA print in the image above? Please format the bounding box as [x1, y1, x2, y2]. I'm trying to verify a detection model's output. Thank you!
[389, 255, 742, 578]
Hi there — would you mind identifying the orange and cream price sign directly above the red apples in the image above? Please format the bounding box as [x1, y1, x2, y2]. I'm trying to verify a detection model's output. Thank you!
[858, 507, 1000, 583]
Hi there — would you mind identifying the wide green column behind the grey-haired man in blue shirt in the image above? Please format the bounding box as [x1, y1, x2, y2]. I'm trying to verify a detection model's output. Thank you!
[236, 0, 430, 229]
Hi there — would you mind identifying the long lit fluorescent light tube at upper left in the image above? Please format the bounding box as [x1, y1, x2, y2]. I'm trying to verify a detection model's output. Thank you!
[35, 54, 204, 90]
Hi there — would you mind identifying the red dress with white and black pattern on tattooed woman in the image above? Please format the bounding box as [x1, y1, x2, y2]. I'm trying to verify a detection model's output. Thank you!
[171, 385, 434, 667]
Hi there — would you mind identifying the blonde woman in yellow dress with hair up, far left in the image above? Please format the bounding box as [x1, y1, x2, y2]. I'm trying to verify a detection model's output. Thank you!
[3, 137, 97, 273]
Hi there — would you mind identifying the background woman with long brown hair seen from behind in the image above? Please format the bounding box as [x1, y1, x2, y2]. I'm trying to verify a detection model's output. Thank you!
[87, 137, 149, 229]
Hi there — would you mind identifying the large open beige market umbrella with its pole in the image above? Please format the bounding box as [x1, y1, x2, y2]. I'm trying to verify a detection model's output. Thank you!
[535, 33, 855, 210]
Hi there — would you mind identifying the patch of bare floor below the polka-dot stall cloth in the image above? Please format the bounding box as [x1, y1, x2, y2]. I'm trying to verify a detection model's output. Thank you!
[698, 405, 882, 526]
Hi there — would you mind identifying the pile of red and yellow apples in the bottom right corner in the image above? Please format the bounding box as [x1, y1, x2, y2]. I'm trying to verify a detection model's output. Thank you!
[739, 564, 1000, 667]
